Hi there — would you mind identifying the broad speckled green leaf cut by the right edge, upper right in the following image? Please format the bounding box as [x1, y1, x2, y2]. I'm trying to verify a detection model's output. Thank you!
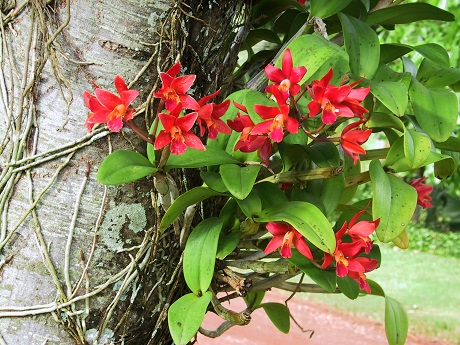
[409, 78, 458, 142]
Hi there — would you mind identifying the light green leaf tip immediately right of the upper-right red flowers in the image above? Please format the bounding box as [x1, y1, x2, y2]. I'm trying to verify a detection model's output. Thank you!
[361, 79, 409, 116]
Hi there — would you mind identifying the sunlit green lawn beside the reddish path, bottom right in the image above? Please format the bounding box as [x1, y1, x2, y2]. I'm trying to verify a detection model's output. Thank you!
[302, 247, 460, 344]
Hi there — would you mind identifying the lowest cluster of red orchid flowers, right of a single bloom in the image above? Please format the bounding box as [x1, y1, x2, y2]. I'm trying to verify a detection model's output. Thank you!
[321, 207, 380, 293]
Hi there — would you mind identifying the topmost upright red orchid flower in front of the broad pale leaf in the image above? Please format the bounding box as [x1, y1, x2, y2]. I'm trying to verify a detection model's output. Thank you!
[265, 47, 307, 99]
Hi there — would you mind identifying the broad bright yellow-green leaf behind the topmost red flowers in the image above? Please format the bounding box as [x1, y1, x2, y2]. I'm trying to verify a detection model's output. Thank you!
[284, 34, 349, 84]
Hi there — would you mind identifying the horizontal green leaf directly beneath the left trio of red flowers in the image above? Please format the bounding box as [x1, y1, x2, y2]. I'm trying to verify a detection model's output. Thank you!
[165, 147, 239, 170]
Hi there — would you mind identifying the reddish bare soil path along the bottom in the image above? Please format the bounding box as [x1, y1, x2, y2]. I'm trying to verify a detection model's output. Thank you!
[196, 291, 453, 345]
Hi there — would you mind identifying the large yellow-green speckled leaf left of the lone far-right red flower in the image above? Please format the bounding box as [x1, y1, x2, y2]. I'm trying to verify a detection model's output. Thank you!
[369, 159, 417, 242]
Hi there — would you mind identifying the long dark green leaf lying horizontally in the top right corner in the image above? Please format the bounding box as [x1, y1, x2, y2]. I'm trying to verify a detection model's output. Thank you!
[366, 3, 455, 25]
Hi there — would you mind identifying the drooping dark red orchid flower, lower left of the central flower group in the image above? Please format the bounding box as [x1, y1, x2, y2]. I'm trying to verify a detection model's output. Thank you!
[227, 102, 272, 165]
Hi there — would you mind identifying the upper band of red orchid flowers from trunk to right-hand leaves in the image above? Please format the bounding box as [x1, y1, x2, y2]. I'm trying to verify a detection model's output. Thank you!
[83, 49, 372, 165]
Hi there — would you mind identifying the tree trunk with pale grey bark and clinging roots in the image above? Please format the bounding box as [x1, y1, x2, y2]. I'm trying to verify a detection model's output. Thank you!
[0, 0, 244, 345]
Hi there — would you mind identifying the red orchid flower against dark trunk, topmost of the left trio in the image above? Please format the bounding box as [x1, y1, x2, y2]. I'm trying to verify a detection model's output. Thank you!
[153, 62, 200, 111]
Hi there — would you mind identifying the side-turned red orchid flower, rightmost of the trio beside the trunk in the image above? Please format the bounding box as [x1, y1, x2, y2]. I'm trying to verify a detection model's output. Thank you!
[197, 90, 232, 139]
